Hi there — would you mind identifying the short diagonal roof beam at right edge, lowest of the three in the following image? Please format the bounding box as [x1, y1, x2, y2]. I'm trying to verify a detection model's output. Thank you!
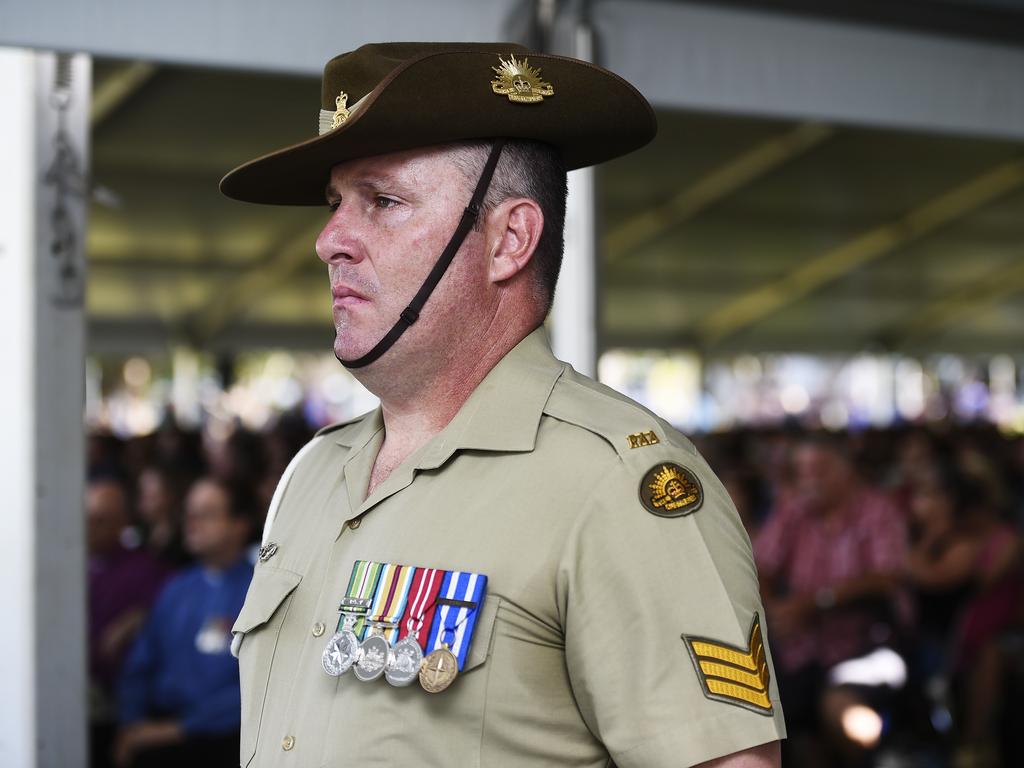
[891, 259, 1024, 348]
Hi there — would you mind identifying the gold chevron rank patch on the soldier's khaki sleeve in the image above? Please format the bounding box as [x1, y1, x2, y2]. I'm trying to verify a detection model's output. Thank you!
[683, 613, 774, 715]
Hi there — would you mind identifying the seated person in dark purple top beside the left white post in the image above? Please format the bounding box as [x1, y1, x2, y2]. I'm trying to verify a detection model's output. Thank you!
[85, 477, 169, 768]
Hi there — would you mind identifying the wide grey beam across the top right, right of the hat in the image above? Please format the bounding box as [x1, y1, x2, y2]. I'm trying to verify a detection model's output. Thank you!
[591, 0, 1024, 139]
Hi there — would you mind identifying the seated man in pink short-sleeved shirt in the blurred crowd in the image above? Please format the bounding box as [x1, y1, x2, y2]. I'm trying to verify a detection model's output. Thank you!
[755, 438, 906, 765]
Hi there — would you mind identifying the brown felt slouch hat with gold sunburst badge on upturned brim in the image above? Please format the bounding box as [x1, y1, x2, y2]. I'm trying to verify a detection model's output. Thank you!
[220, 43, 657, 205]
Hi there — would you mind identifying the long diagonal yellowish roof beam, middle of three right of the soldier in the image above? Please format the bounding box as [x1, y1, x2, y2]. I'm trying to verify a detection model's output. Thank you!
[696, 160, 1024, 346]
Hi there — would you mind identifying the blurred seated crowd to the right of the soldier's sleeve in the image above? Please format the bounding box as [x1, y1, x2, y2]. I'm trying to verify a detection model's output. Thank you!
[699, 425, 1024, 768]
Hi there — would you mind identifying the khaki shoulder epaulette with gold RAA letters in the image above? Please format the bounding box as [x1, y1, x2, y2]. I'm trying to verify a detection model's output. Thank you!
[544, 371, 696, 464]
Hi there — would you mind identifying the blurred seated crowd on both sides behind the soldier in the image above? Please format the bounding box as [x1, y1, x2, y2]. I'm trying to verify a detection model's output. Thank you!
[87, 416, 1024, 768]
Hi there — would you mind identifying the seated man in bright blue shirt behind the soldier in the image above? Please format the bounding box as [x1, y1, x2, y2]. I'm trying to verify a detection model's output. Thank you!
[115, 477, 253, 768]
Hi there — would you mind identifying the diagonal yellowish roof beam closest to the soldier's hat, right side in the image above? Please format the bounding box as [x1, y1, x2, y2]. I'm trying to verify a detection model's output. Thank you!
[603, 123, 836, 262]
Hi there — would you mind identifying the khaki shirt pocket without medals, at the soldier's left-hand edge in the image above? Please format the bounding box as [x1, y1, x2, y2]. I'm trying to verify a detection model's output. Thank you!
[231, 564, 302, 766]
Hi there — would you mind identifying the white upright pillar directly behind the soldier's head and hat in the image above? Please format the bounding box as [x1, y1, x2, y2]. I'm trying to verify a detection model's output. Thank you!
[551, 25, 597, 377]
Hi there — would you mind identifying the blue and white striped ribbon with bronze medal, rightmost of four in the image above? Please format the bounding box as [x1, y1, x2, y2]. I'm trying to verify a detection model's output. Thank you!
[420, 570, 487, 693]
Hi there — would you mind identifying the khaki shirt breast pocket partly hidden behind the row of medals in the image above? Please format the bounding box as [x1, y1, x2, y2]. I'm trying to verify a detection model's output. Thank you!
[319, 595, 501, 768]
